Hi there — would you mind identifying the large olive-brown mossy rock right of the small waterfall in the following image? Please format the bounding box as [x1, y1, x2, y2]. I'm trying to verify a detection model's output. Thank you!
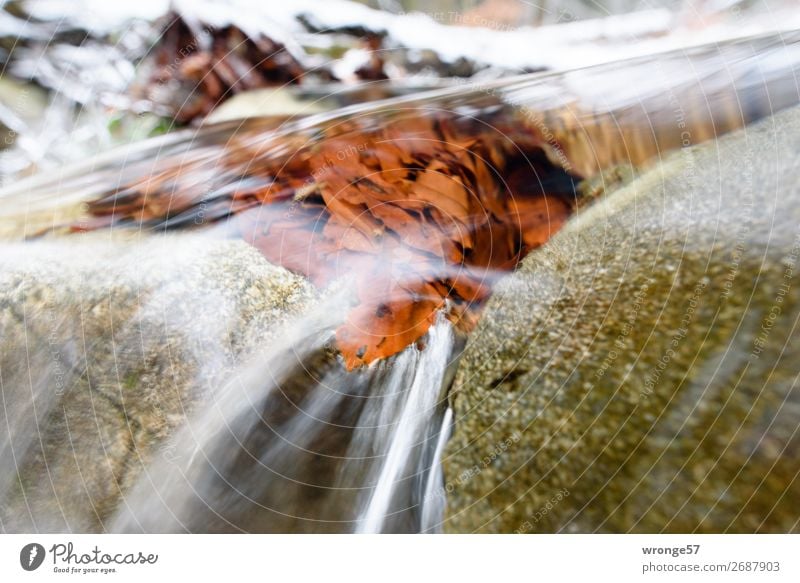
[444, 104, 800, 532]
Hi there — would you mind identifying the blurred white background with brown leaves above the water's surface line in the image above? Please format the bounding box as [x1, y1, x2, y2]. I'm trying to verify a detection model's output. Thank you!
[0, 0, 798, 185]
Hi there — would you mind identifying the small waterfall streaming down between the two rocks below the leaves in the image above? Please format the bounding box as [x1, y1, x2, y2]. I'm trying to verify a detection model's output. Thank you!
[112, 305, 454, 532]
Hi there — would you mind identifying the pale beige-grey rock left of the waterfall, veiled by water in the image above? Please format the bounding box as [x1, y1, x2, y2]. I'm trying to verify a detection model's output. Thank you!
[0, 235, 314, 532]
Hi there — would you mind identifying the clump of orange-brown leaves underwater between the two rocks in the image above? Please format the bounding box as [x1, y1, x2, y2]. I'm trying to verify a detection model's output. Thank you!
[70, 110, 575, 368]
